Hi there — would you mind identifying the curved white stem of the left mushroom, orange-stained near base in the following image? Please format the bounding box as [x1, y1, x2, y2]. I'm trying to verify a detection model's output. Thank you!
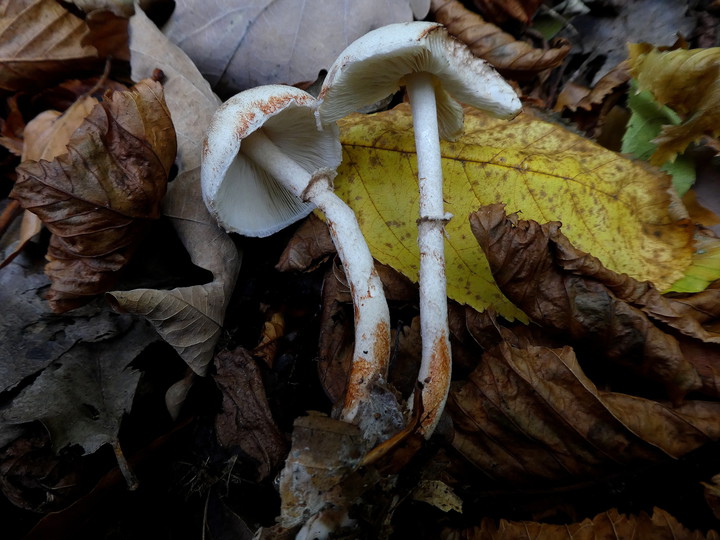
[241, 129, 390, 423]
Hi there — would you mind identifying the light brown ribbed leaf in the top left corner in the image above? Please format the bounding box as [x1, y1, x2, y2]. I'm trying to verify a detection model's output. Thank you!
[0, 0, 100, 91]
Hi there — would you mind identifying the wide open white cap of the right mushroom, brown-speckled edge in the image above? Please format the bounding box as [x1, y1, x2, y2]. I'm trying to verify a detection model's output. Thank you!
[316, 22, 521, 139]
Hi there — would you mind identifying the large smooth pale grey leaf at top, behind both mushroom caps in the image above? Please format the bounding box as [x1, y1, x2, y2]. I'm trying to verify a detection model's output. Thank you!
[163, 0, 427, 94]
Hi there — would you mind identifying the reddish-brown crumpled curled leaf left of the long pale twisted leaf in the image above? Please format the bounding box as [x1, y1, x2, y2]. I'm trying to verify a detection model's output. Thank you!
[11, 77, 175, 312]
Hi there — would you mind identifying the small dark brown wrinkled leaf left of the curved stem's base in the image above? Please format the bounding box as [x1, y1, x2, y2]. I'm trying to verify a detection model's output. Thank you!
[213, 349, 288, 481]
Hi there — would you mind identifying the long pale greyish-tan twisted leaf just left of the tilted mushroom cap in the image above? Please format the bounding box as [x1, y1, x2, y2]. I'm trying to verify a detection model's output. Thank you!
[110, 9, 240, 375]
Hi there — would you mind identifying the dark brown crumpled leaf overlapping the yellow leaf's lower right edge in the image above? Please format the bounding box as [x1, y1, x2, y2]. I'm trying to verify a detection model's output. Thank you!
[470, 204, 701, 399]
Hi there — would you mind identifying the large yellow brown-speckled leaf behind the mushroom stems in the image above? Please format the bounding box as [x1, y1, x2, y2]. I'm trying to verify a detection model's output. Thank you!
[335, 105, 692, 320]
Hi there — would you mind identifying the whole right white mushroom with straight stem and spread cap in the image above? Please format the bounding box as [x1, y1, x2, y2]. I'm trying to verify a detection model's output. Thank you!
[316, 22, 521, 437]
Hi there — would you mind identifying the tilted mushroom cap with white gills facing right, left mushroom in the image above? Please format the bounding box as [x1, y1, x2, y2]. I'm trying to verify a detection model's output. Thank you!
[200, 85, 342, 237]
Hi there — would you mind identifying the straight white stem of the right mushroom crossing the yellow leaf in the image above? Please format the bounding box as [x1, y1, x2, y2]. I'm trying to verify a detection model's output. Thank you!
[405, 72, 452, 438]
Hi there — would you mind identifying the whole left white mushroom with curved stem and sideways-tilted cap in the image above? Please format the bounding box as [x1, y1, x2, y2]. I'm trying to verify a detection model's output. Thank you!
[201, 85, 390, 422]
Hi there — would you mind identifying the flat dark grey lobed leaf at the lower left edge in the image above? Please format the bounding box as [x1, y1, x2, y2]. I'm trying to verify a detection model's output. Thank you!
[0, 255, 159, 460]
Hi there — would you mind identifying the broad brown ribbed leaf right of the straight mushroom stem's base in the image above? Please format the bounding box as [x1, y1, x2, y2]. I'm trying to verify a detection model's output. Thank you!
[448, 343, 720, 485]
